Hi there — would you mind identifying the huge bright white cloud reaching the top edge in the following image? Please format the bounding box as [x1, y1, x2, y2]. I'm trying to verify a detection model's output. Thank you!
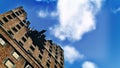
[50, 0, 102, 41]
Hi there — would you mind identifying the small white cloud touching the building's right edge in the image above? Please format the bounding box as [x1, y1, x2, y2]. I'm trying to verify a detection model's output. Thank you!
[63, 45, 84, 64]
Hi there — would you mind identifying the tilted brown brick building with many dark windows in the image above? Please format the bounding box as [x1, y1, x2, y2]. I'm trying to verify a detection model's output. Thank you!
[0, 7, 64, 68]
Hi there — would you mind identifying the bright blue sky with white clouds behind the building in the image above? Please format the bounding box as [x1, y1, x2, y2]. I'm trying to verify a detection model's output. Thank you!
[0, 0, 120, 68]
